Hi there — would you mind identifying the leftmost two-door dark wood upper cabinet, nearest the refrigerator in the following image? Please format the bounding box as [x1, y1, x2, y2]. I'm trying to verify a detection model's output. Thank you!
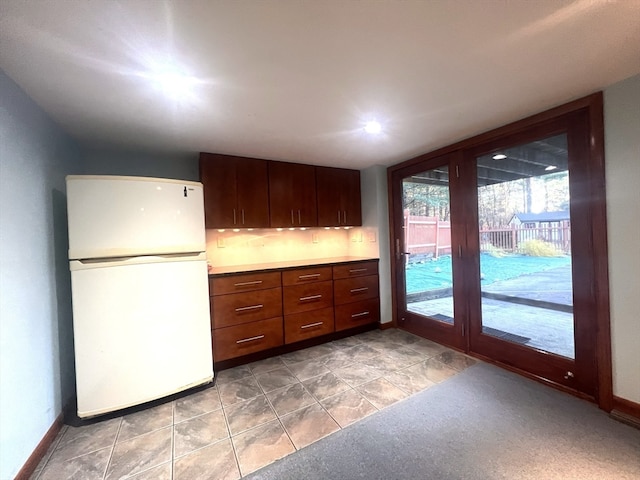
[200, 153, 269, 228]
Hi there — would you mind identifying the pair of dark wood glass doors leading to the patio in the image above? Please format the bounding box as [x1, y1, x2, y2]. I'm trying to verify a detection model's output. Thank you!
[390, 97, 608, 397]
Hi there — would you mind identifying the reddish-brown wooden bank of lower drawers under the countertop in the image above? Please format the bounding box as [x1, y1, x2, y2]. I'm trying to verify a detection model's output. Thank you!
[209, 260, 380, 362]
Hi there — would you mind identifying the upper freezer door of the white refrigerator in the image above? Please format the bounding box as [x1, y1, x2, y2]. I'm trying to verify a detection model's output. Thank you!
[67, 175, 206, 259]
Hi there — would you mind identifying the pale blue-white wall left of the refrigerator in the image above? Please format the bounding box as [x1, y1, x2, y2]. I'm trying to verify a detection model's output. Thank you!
[0, 70, 78, 479]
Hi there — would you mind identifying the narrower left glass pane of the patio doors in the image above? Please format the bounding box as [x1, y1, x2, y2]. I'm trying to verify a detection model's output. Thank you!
[402, 167, 453, 324]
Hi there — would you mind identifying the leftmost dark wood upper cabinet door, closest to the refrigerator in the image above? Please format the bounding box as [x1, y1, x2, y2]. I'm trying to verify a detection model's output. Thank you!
[200, 153, 237, 228]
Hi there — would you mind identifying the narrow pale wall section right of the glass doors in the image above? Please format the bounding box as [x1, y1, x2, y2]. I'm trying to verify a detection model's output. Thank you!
[604, 75, 640, 403]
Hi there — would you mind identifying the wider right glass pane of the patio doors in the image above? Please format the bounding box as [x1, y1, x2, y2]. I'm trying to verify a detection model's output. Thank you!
[477, 134, 575, 358]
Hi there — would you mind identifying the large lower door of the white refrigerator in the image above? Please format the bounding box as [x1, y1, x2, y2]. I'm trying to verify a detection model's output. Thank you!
[71, 254, 213, 418]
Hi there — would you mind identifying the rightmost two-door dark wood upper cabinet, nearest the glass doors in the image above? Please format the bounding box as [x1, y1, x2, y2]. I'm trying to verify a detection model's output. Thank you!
[315, 167, 362, 227]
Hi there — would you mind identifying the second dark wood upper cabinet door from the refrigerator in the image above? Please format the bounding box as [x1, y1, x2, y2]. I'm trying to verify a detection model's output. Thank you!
[234, 157, 269, 228]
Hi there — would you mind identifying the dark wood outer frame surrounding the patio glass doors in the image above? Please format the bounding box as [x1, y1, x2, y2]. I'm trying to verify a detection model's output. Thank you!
[387, 92, 613, 412]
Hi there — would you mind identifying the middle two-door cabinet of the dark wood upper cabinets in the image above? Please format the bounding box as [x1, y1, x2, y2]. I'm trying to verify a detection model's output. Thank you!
[268, 162, 318, 227]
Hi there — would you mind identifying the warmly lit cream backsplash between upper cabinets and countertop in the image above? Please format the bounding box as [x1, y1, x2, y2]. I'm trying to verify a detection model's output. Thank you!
[207, 227, 379, 267]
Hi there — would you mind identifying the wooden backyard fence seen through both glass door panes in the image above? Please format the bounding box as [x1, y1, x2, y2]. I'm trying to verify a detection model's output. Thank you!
[404, 212, 571, 261]
